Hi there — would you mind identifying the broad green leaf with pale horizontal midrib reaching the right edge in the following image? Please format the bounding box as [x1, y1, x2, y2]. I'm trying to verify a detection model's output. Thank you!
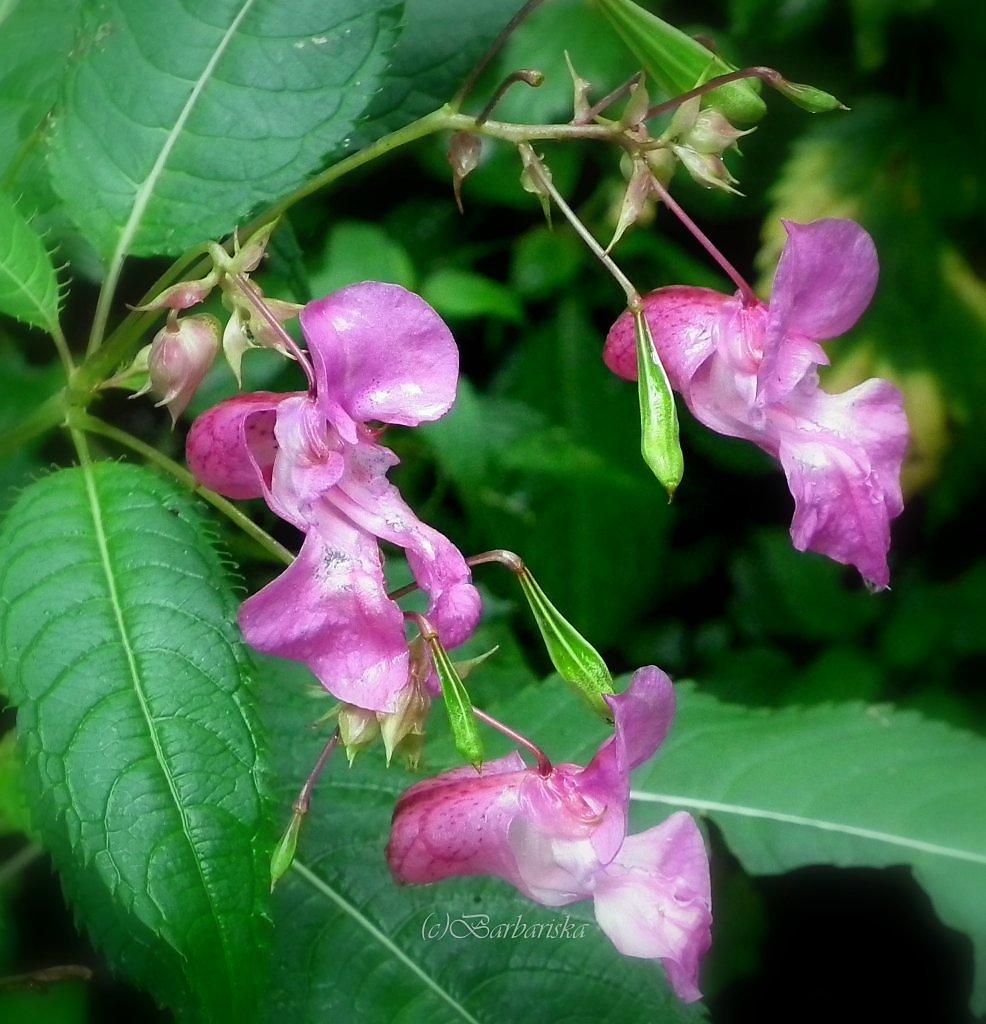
[498, 683, 986, 1007]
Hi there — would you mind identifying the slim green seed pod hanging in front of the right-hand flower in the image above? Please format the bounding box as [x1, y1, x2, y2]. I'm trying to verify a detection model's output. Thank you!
[633, 309, 685, 500]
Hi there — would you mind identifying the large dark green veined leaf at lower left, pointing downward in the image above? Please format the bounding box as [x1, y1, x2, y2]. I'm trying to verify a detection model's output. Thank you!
[0, 463, 269, 1024]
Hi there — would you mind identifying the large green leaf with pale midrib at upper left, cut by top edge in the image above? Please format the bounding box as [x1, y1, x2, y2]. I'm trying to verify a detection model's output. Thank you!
[51, 0, 399, 261]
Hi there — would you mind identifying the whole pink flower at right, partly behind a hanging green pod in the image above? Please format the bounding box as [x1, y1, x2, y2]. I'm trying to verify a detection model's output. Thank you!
[604, 220, 907, 588]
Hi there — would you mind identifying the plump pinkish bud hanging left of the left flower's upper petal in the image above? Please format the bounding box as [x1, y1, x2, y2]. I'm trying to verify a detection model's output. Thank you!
[147, 313, 219, 423]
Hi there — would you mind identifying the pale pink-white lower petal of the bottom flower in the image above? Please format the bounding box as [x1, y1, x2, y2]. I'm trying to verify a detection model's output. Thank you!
[594, 812, 712, 1002]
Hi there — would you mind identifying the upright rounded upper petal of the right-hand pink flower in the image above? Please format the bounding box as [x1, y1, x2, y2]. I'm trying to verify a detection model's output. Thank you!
[759, 218, 880, 402]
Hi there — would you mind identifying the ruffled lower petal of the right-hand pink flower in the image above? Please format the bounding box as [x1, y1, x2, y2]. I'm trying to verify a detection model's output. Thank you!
[779, 380, 907, 588]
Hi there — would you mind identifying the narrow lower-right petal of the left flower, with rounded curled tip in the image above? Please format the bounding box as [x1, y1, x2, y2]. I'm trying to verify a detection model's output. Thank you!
[330, 441, 481, 647]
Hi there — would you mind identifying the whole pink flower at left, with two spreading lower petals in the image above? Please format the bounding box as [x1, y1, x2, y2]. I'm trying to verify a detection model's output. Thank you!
[187, 282, 480, 712]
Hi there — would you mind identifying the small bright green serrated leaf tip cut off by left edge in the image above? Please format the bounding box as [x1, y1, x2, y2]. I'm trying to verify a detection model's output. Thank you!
[0, 191, 58, 333]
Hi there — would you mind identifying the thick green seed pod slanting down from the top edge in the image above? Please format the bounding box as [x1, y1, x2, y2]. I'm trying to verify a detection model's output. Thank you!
[596, 0, 767, 124]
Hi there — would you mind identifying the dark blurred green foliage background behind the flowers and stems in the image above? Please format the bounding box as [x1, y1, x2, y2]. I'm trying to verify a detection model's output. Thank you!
[0, 0, 986, 1022]
